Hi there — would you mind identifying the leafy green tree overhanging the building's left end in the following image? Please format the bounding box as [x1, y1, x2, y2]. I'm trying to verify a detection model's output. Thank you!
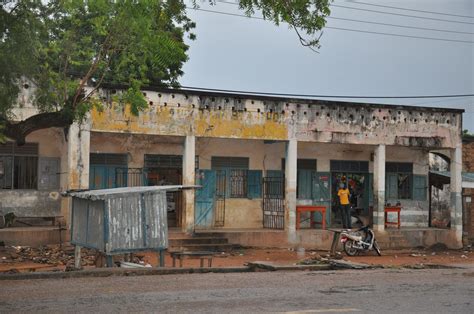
[0, 0, 329, 144]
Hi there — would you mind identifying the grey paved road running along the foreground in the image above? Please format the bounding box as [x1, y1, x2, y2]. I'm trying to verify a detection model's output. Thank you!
[0, 268, 474, 313]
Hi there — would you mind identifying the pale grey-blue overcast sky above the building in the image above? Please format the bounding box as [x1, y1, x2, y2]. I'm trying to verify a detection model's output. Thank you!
[180, 0, 474, 132]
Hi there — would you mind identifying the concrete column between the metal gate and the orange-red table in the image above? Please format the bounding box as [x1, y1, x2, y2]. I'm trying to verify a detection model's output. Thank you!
[285, 139, 298, 244]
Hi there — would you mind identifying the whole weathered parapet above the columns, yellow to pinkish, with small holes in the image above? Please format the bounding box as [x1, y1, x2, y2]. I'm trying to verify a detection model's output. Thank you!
[92, 91, 461, 148]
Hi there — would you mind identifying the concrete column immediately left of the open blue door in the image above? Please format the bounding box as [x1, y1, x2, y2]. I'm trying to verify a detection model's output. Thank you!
[182, 135, 196, 234]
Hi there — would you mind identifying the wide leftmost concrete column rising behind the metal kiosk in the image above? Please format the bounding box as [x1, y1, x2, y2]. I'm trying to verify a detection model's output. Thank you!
[67, 121, 90, 190]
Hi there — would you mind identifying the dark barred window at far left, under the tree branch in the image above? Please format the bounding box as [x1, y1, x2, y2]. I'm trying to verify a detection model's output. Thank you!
[0, 142, 38, 189]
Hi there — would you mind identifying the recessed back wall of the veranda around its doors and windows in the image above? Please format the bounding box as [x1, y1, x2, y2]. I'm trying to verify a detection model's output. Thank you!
[91, 132, 429, 228]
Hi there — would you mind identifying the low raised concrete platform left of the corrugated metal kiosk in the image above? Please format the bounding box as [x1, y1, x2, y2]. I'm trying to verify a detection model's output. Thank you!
[0, 226, 69, 247]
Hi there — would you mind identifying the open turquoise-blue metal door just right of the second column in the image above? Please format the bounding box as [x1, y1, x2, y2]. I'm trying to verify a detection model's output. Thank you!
[194, 170, 216, 228]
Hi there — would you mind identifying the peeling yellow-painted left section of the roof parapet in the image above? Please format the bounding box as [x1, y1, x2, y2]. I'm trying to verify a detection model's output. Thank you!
[91, 106, 288, 140]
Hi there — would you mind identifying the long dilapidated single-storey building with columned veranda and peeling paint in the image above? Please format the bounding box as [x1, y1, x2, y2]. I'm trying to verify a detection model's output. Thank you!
[0, 89, 463, 247]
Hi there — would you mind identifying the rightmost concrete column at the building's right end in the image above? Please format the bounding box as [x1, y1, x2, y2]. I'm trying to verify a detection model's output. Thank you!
[449, 143, 462, 248]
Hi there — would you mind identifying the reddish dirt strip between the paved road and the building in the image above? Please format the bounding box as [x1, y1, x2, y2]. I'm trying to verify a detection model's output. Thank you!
[0, 248, 474, 273]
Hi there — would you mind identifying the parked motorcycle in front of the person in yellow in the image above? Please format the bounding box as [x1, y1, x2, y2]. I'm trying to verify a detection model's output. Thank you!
[341, 226, 382, 256]
